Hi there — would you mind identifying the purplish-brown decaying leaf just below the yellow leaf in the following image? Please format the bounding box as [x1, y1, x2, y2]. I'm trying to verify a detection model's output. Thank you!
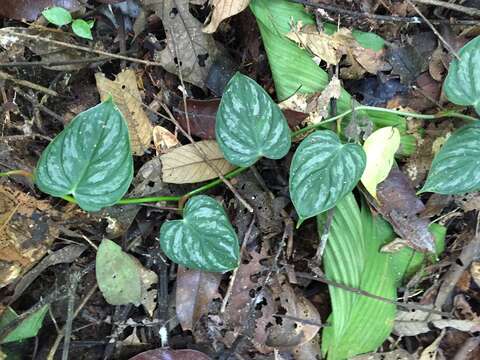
[373, 169, 435, 253]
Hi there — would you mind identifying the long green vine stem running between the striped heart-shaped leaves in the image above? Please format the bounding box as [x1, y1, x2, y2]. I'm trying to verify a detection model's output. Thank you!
[0, 105, 479, 209]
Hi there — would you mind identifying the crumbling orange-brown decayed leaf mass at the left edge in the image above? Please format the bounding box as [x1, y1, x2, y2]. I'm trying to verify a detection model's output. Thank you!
[0, 186, 59, 288]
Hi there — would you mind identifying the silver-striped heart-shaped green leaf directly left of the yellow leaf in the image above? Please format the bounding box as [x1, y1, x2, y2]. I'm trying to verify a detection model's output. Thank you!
[289, 130, 366, 220]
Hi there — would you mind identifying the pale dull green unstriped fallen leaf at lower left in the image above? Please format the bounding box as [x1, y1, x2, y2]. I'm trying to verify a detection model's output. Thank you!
[95, 239, 142, 305]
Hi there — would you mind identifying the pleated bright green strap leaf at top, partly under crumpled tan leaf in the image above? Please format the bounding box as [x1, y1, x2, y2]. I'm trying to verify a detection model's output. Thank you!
[250, 0, 414, 154]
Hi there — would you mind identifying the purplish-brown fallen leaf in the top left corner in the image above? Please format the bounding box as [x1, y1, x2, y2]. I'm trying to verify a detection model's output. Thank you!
[0, 0, 82, 21]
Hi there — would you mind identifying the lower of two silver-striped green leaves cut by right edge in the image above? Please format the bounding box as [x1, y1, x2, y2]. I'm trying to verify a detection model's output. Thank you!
[420, 122, 480, 194]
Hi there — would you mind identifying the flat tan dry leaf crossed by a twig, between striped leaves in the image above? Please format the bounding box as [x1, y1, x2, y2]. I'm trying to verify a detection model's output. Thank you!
[160, 140, 235, 184]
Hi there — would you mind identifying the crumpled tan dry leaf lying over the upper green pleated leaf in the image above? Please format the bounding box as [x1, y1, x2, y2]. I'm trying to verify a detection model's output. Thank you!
[287, 23, 388, 79]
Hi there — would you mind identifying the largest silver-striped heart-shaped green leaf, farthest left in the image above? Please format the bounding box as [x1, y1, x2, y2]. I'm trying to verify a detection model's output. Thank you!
[36, 100, 133, 211]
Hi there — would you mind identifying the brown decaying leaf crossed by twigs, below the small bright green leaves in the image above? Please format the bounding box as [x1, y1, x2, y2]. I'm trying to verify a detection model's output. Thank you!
[0, 27, 86, 71]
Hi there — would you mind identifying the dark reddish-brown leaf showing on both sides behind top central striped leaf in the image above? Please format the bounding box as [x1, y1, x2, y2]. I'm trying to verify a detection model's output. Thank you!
[172, 99, 307, 140]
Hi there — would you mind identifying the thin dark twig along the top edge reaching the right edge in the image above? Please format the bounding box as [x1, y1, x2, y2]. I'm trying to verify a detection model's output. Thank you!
[290, 0, 478, 25]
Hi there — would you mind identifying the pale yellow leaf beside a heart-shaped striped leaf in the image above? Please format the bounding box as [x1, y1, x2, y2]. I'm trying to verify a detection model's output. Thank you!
[361, 126, 400, 198]
